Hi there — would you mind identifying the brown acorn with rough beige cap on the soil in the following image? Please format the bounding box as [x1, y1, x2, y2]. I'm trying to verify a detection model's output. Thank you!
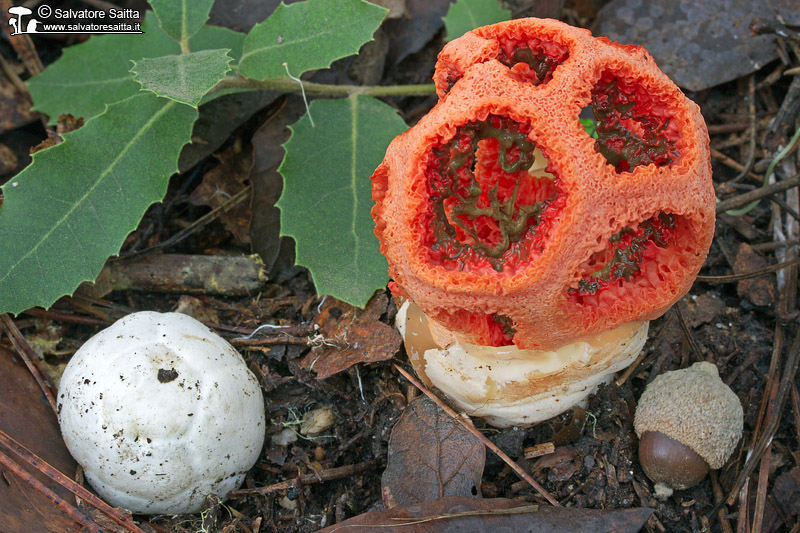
[633, 362, 744, 497]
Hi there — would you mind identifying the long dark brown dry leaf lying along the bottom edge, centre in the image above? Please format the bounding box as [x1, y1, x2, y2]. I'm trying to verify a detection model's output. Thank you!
[322, 496, 653, 533]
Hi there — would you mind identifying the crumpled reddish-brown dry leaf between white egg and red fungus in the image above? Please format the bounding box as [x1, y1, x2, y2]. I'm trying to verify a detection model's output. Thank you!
[303, 292, 403, 379]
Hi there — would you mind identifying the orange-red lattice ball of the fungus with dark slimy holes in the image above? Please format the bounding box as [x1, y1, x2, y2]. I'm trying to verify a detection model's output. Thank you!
[372, 19, 715, 349]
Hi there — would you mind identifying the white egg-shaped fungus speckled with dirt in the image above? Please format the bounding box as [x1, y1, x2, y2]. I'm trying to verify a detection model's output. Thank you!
[58, 311, 264, 514]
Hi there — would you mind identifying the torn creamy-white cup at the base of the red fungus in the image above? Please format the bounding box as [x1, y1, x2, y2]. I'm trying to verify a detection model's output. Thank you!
[396, 302, 648, 427]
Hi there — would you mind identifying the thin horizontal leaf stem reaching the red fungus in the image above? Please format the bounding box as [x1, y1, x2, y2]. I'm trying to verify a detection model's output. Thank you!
[210, 76, 436, 98]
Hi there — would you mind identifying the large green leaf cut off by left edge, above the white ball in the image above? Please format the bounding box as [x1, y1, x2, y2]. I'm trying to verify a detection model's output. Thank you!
[0, 93, 197, 313]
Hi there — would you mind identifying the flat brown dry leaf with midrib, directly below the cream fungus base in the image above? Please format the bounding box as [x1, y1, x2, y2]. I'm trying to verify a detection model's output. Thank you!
[381, 396, 486, 509]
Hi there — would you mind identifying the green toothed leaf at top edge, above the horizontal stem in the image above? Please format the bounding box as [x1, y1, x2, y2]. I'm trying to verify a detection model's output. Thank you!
[239, 0, 388, 80]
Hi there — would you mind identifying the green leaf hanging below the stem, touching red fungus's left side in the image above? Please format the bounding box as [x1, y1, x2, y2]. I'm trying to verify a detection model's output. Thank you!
[278, 96, 406, 307]
